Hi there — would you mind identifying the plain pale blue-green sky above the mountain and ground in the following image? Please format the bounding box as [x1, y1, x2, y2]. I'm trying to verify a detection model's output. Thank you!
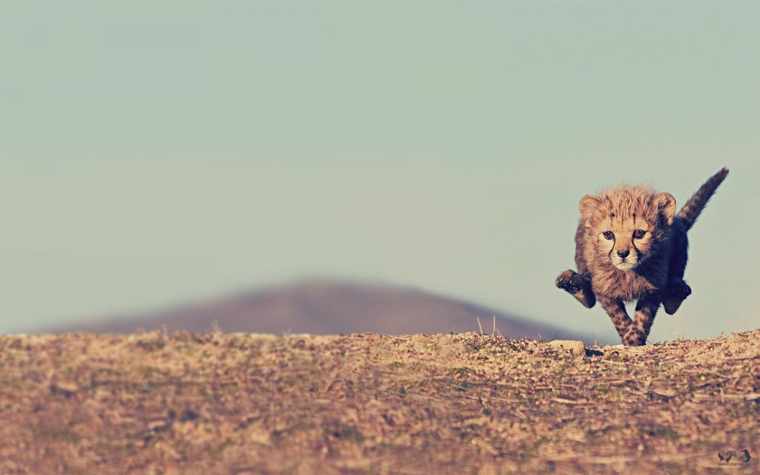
[0, 0, 760, 341]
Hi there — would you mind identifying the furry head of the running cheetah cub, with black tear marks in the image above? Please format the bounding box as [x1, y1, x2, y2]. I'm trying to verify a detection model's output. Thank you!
[580, 186, 676, 272]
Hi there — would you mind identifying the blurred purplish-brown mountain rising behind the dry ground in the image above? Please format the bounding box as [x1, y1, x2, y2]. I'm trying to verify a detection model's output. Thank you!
[52, 280, 582, 339]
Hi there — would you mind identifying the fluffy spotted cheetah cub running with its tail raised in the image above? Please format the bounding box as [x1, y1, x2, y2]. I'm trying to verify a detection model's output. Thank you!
[556, 168, 728, 346]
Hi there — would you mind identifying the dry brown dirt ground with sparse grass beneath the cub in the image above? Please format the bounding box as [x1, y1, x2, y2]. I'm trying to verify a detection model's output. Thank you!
[0, 331, 760, 475]
